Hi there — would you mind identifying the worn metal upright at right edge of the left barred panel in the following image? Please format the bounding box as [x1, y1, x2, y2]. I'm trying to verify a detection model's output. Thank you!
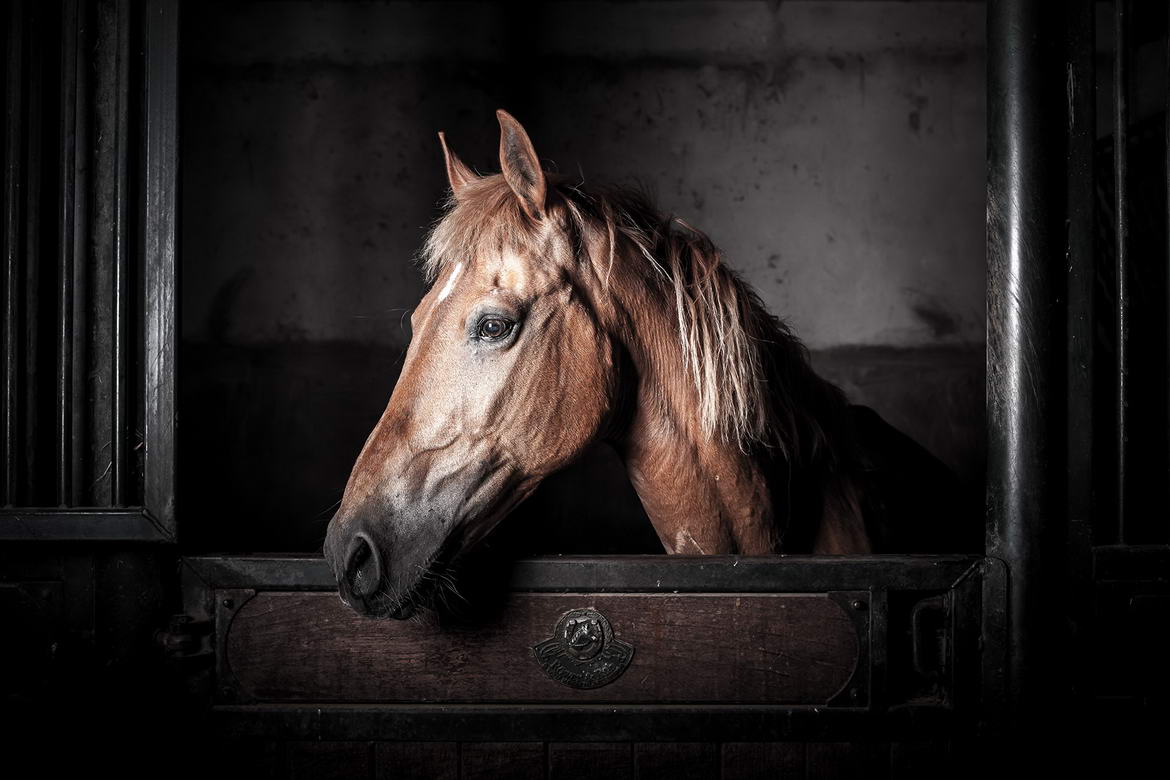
[143, 0, 179, 533]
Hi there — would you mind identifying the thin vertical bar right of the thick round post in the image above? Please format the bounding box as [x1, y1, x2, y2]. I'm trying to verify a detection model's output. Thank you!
[1113, 0, 1129, 544]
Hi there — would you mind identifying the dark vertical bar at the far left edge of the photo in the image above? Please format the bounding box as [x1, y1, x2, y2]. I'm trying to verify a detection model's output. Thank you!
[0, 0, 25, 506]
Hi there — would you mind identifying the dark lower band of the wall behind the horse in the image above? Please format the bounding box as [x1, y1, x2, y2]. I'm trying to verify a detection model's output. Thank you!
[180, 344, 985, 554]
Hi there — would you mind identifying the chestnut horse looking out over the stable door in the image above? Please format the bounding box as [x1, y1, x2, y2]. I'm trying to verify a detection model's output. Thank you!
[324, 110, 962, 619]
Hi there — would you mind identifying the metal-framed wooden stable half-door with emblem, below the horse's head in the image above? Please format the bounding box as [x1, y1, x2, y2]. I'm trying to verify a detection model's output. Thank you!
[185, 557, 1004, 741]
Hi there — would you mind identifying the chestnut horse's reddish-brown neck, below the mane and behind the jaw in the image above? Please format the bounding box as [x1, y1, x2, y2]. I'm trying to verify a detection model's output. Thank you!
[594, 240, 869, 555]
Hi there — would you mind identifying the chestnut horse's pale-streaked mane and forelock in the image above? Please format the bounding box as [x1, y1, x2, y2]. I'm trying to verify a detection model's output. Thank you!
[419, 175, 845, 463]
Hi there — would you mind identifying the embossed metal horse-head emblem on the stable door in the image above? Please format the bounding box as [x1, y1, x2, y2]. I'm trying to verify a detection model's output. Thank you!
[532, 609, 634, 689]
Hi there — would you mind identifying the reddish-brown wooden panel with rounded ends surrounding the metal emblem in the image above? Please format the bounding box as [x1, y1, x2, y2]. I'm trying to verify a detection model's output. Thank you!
[226, 593, 858, 704]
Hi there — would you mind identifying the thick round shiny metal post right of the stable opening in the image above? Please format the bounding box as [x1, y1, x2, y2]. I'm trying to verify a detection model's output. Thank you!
[987, 0, 1067, 716]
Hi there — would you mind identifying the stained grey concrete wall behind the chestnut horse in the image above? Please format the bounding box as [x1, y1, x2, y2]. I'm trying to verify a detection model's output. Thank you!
[183, 1, 984, 547]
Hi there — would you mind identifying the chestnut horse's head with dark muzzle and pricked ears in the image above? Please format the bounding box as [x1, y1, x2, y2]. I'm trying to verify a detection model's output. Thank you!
[325, 111, 619, 617]
